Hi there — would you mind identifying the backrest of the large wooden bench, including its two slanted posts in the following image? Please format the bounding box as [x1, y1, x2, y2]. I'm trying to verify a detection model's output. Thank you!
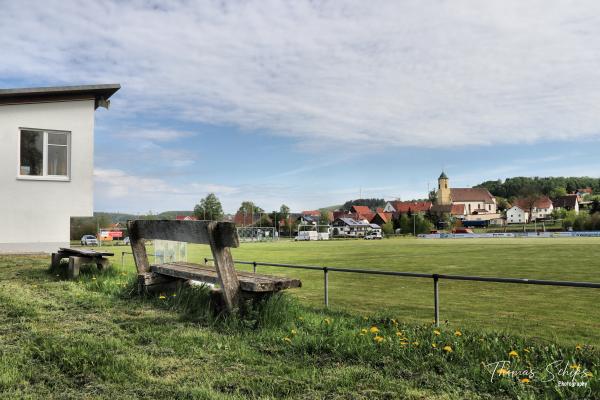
[127, 220, 240, 311]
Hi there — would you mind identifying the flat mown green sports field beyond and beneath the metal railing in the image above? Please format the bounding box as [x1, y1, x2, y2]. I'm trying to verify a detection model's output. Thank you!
[111, 238, 600, 343]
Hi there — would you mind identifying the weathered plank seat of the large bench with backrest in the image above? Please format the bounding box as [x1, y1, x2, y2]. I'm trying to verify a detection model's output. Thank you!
[150, 262, 302, 292]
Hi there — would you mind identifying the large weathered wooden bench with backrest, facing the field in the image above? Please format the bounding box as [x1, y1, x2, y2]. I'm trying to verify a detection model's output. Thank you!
[127, 220, 302, 312]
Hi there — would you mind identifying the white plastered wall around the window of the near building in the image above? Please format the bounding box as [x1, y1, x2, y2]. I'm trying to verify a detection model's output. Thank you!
[0, 100, 94, 253]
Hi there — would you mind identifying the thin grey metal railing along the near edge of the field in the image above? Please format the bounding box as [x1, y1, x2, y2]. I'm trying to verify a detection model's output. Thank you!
[204, 257, 600, 326]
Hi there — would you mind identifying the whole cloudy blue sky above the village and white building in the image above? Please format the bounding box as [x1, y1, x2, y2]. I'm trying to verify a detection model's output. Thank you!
[0, 0, 600, 213]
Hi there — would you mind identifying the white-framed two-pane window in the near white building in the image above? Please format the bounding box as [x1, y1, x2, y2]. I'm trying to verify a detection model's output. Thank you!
[19, 128, 71, 179]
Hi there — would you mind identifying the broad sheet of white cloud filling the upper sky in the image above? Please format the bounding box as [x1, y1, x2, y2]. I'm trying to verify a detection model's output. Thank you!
[0, 0, 600, 150]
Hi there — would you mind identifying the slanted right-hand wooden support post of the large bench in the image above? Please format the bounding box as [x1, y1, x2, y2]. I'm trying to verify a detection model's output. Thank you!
[207, 222, 240, 312]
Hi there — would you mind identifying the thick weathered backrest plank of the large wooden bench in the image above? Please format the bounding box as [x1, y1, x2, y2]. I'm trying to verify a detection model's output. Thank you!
[127, 220, 240, 247]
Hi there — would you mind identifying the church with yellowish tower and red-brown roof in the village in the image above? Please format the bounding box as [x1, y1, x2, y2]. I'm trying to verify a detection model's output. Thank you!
[431, 172, 499, 220]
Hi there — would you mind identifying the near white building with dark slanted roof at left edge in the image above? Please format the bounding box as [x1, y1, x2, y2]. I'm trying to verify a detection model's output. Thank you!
[0, 84, 120, 253]
